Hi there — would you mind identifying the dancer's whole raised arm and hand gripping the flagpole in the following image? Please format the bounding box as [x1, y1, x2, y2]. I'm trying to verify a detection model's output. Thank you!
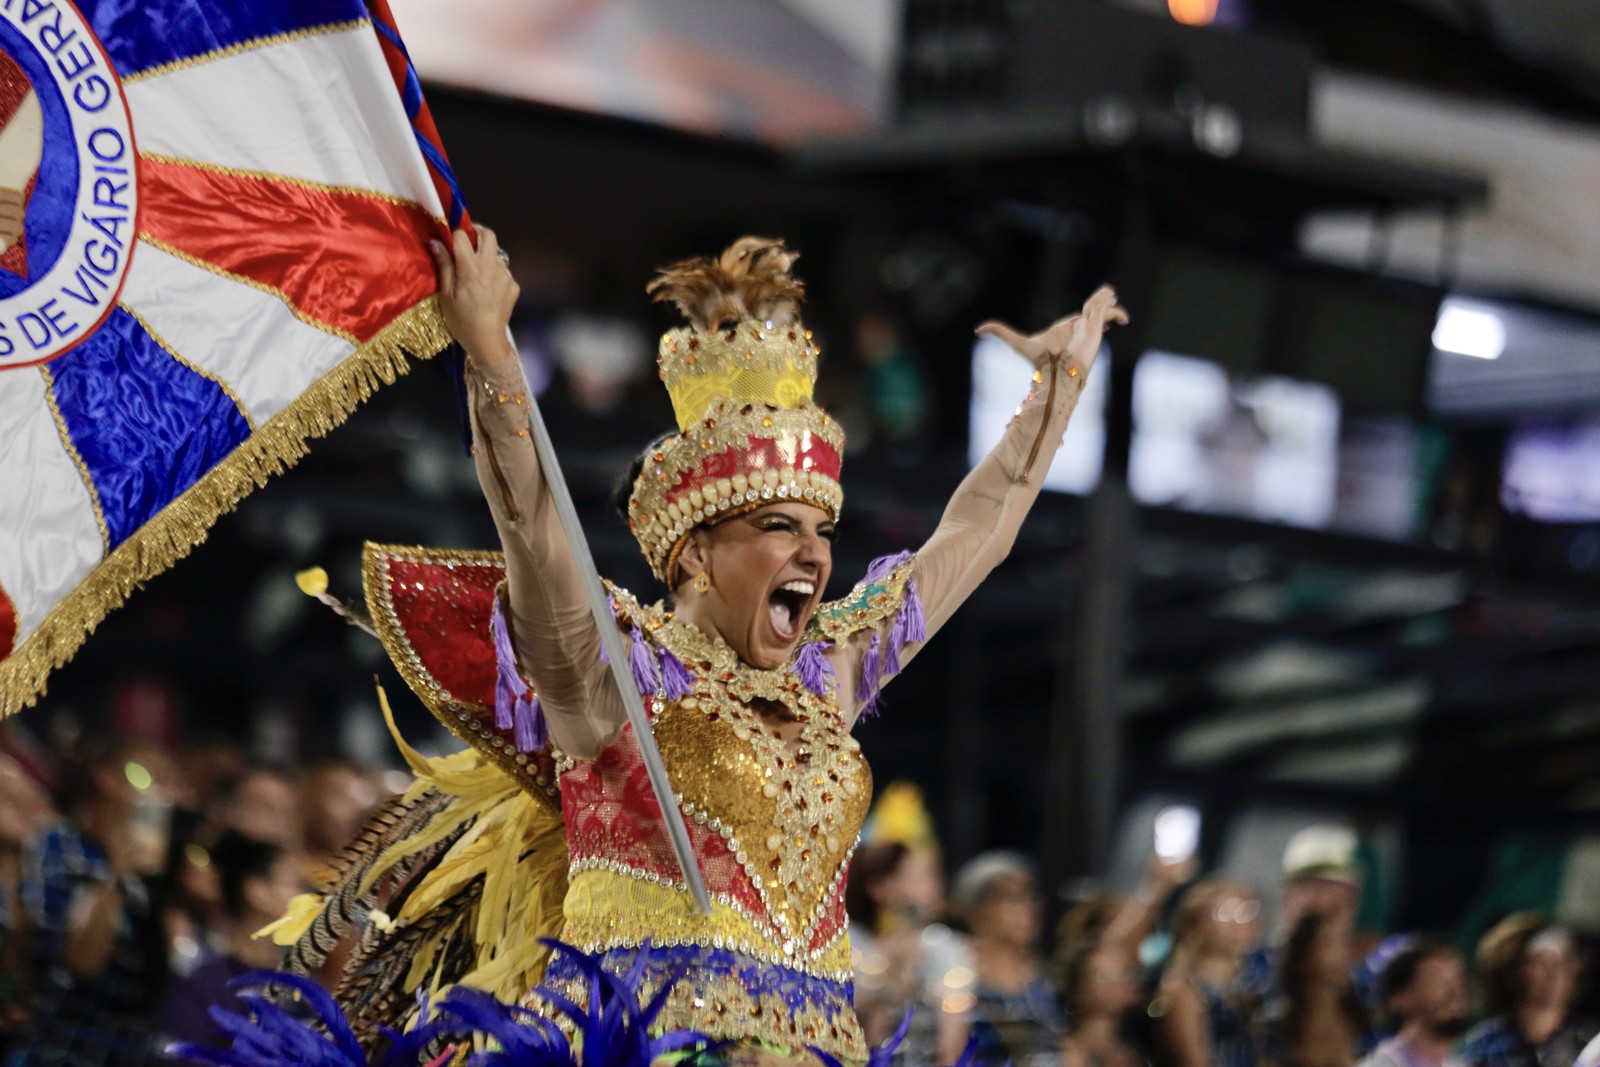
[432, 226, 624, 758]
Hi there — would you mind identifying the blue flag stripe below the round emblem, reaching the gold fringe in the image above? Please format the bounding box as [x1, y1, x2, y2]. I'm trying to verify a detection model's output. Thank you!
[50, 307, 250, 549]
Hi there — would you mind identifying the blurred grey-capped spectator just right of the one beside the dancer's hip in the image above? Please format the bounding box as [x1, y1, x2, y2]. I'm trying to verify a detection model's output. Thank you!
[952, 853, 1066, 1067]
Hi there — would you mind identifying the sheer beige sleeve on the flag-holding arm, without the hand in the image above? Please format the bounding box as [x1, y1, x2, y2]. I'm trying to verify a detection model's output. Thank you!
[467, 363, 626, 758]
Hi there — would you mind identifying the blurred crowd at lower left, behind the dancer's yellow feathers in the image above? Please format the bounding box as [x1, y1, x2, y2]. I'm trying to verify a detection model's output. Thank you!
[0, 733, 381, 1067]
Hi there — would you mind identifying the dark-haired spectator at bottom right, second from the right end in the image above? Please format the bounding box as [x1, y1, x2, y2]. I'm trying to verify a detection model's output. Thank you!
[1362, 939, 1467, 1067]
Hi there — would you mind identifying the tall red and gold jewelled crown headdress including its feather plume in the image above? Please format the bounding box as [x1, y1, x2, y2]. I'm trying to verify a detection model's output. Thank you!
[627, 237, 845, 585]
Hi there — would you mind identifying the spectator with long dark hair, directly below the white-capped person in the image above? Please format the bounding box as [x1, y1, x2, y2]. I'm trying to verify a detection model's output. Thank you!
[1275, 910, 1368, 1067]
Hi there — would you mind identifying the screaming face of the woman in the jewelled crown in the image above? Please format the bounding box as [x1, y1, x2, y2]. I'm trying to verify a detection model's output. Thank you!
[677, 502, 835, 670]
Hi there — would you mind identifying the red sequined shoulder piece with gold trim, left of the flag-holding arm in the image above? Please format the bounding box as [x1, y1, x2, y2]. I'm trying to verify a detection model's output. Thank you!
[362, 542, 560, 811]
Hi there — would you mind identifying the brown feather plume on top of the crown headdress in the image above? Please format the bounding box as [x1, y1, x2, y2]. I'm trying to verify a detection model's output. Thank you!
[645, 237, 805, 330]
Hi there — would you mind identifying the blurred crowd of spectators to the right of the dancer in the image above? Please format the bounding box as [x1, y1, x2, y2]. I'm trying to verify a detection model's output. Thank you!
[848, 799, 1600, 1067]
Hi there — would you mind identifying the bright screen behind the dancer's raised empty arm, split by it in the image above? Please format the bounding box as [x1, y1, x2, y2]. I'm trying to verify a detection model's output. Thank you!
[966, 338, 1110, 493]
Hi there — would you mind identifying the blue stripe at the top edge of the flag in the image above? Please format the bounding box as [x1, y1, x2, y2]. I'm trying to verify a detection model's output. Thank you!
[78, 0, 366, 78]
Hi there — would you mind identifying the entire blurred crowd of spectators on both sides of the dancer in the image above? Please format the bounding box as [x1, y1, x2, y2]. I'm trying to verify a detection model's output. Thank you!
[0, 737, 1600, 1067]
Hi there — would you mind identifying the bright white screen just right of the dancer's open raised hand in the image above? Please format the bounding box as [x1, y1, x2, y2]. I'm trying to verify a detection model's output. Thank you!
[1128, 352, 1339, 528]
